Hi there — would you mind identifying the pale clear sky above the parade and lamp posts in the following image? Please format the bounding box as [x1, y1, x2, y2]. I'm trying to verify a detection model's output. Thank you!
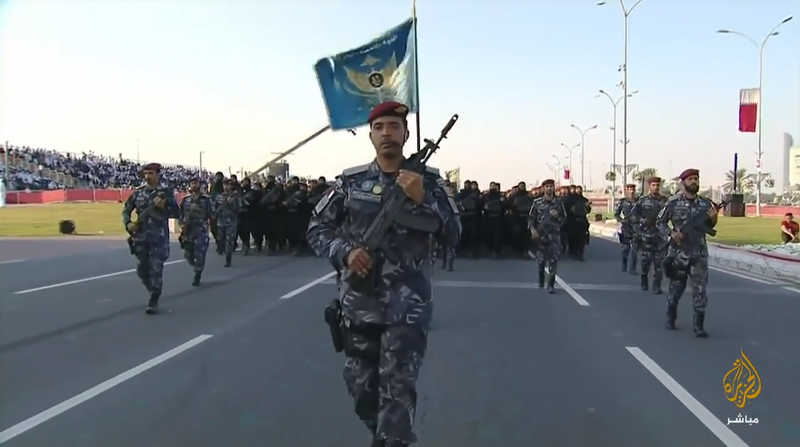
[0, 0, 800, 188]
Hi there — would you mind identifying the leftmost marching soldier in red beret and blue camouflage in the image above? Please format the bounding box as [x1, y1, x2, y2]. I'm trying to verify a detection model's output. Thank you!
[122, 163, 180, 315]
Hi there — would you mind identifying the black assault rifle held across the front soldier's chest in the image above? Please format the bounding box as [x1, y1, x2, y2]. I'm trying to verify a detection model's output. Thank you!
[345, 115, 458, 295]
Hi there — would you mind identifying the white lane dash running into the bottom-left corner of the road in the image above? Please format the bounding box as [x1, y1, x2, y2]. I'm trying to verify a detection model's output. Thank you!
[0, 335, 213, 444]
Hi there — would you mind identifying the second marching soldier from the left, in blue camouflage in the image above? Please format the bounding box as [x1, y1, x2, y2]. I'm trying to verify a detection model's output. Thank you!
[180, 178, 214, 287]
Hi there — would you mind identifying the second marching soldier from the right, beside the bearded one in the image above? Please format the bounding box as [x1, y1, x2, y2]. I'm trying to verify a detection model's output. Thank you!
[631, 177, 667, 295]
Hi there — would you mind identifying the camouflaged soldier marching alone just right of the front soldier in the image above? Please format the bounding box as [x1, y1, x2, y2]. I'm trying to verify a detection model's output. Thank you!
[528, 180, 567, 293]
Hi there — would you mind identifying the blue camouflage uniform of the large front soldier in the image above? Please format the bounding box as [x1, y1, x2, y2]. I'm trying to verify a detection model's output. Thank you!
[307, 161, 461, 445]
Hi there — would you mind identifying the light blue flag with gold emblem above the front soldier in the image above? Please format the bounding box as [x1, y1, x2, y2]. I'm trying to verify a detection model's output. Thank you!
[314, 18, 419, 130]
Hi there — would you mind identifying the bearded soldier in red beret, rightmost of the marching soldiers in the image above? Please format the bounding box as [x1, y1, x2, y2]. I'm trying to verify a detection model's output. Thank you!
[657, 169, 717, 338]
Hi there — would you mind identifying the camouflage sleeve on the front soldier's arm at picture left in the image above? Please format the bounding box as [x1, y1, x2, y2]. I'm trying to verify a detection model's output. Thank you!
[306, 175, 355, 270]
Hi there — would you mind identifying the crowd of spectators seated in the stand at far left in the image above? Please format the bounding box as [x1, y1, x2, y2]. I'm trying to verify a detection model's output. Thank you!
[0, 146, 213, 191]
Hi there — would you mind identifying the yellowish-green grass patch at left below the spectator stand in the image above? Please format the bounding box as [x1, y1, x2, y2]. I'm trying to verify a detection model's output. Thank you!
[0, 203, 126, 237]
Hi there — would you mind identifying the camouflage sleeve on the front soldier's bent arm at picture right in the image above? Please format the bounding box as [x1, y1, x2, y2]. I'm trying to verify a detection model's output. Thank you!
[422, 172, 461, 247]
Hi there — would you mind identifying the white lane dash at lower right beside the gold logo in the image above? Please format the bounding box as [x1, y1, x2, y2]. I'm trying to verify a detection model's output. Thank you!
[625, 346, 749, 447]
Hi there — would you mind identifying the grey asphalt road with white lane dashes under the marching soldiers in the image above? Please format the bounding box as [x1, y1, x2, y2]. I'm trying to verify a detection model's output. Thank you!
[0, 239, 800, 447]
